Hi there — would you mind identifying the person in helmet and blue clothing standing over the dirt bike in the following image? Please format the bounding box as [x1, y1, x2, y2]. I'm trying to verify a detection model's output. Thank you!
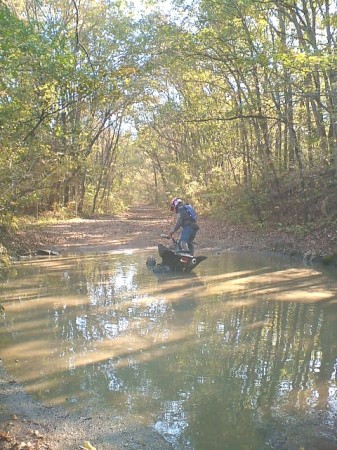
[169, 197, 199, 255]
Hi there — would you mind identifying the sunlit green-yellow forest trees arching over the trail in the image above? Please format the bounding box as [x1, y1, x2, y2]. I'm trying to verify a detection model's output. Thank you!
[0, 0, 337, 225]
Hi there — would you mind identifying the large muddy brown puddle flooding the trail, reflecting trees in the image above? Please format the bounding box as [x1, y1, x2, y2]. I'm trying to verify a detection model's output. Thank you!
[0, 253, 337, 450]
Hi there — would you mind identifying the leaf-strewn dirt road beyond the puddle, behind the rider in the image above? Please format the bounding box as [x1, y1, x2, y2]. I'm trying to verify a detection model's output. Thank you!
[19, 205, 337, 258]
